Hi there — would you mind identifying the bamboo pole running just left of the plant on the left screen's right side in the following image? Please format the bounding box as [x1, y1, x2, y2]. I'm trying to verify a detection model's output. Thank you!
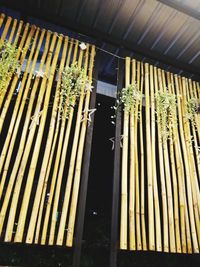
[26, 37, 68, 243]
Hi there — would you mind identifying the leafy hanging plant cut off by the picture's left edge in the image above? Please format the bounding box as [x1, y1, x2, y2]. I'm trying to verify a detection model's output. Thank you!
[0, 41, 19, 96]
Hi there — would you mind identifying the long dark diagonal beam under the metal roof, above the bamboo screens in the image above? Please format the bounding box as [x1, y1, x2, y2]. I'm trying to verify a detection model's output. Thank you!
[1, 0, 200, 76]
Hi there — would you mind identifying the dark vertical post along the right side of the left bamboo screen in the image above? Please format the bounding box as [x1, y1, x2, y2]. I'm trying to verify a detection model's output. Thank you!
[73, 51, 100, 267]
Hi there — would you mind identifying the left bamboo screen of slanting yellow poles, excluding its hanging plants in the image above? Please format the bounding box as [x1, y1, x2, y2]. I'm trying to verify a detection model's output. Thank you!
[0, 14, 95, 247]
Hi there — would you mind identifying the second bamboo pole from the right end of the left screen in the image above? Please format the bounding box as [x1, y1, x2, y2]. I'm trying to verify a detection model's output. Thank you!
[56, 46, 89, 245]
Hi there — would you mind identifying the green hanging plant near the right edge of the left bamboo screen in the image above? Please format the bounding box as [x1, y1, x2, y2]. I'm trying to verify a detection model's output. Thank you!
[60, 62, 88, 119]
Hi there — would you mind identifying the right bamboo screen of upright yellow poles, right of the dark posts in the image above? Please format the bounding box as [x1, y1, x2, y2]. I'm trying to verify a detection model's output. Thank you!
[120, 58, 200, 253]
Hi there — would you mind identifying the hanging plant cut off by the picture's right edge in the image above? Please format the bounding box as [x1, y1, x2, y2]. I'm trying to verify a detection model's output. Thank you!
[186, 97, 200, 126]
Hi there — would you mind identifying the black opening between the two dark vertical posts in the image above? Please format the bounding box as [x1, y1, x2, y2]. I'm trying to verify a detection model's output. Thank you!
[81, 94, 115, 267]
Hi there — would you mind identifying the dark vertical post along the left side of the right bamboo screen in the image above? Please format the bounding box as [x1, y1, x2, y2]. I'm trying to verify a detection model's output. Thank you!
[110, 59, 124, 267]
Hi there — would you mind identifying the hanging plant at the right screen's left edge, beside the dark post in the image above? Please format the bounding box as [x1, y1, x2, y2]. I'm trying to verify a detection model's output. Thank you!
[111, 83, 143, 124]
